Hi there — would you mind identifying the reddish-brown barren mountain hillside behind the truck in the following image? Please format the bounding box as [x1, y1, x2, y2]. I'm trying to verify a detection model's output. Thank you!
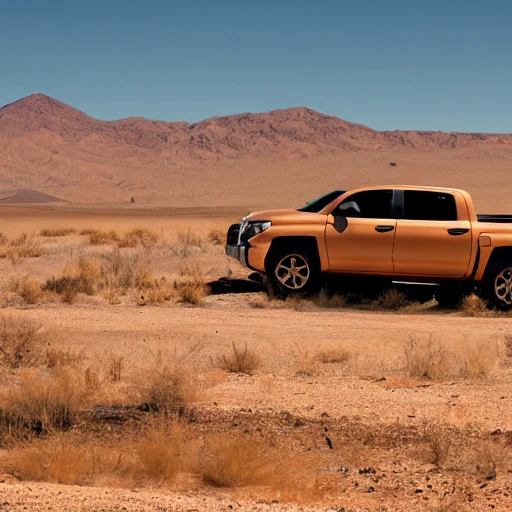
[0, 94, 512, 210]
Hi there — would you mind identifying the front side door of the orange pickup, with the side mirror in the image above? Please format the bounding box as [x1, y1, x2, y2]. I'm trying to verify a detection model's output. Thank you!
[325, 190, 396, 274]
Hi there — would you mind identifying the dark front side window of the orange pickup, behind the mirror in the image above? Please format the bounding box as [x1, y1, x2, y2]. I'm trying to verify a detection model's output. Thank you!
[332, 190, 393, 219]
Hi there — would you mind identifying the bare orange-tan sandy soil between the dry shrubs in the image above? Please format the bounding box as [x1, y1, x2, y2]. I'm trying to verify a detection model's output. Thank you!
[0, 206, 512, 511]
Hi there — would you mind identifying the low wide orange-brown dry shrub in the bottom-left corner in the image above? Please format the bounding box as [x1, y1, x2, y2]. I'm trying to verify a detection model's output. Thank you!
[8, 437, 126, 485]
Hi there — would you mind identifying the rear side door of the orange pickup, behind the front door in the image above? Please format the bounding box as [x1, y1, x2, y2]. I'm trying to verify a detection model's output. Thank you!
[393, 190, 472, 278]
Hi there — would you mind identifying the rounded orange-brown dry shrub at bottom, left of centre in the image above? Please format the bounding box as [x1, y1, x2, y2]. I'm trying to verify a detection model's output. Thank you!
[136, 425, 190, 483]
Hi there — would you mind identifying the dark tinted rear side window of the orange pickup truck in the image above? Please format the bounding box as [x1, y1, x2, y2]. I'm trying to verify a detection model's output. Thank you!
[404, 190, 457, 221]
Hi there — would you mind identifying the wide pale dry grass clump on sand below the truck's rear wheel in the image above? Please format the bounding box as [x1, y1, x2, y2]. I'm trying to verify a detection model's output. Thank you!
[404, 335, 498, 379]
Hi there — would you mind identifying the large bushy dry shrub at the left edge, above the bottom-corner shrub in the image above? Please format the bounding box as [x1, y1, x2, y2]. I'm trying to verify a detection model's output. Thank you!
[1, 368, 87, 435]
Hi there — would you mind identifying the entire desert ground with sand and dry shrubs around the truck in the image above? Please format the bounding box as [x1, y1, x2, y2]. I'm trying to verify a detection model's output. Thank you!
[0, 204, 512, 512]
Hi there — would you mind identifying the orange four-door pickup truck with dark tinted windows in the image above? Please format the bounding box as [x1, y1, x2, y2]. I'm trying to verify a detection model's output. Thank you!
[226, 186, 512, 311]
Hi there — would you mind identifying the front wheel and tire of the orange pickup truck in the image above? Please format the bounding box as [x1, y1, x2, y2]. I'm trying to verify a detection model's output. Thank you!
[267, 246, 320, 298]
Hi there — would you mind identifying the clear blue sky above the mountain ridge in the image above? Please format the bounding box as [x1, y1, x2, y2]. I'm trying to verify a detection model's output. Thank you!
[0, 0, 512, 132]
